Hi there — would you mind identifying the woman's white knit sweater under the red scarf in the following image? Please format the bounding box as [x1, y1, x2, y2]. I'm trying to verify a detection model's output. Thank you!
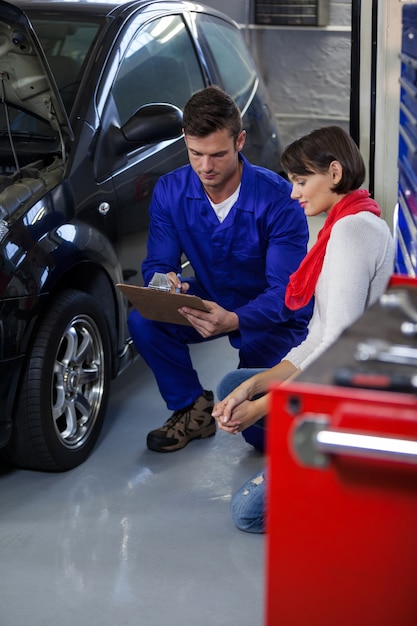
[285, 211, 394, 370]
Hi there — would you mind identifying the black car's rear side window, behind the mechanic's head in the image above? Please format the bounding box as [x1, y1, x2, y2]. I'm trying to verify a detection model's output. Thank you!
[197, 14, 256, 111]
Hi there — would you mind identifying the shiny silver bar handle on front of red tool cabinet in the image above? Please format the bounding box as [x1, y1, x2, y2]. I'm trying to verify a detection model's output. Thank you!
[291, 415, 417, 469]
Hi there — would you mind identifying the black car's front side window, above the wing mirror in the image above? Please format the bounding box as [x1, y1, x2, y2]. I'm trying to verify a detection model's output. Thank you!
[113, 15, 204, 124]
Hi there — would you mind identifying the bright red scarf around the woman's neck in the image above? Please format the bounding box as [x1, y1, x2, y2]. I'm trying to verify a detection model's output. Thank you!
[285, 189, 381, 311]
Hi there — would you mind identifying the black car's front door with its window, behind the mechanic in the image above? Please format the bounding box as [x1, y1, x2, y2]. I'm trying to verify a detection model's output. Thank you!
[93, 14, 205, 284]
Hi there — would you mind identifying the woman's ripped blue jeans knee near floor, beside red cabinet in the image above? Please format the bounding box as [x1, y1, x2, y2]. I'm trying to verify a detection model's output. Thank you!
[230, 470, 265, 533]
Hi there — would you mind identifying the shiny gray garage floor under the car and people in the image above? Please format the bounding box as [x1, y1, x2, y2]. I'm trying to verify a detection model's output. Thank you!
[0, 339, 265, 626]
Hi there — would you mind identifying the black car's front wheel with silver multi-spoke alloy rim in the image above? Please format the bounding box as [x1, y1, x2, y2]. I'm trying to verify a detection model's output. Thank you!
[3, 290, 110, 471]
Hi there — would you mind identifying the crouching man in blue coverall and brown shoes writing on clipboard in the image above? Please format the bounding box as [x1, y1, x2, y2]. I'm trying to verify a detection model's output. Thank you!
[128, 86, 312, 452]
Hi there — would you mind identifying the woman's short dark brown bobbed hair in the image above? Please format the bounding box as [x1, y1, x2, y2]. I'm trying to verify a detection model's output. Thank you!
[281, 126, 365, 194]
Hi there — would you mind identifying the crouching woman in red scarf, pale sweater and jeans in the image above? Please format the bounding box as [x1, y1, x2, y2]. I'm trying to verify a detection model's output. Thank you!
[213, 126, 394, 533]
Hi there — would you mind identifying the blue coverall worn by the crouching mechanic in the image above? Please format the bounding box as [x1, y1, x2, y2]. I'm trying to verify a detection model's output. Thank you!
[128, 154, 312, 411]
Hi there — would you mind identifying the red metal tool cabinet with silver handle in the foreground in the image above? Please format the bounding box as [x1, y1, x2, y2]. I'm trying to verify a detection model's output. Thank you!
[266, 281, 417, 626]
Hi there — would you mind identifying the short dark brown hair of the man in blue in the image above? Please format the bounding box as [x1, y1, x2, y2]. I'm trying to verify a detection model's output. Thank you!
[183, 86, 242, 143]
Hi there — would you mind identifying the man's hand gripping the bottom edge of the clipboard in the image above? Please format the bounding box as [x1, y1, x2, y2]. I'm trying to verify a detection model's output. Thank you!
[178, 300, 239, 339]
